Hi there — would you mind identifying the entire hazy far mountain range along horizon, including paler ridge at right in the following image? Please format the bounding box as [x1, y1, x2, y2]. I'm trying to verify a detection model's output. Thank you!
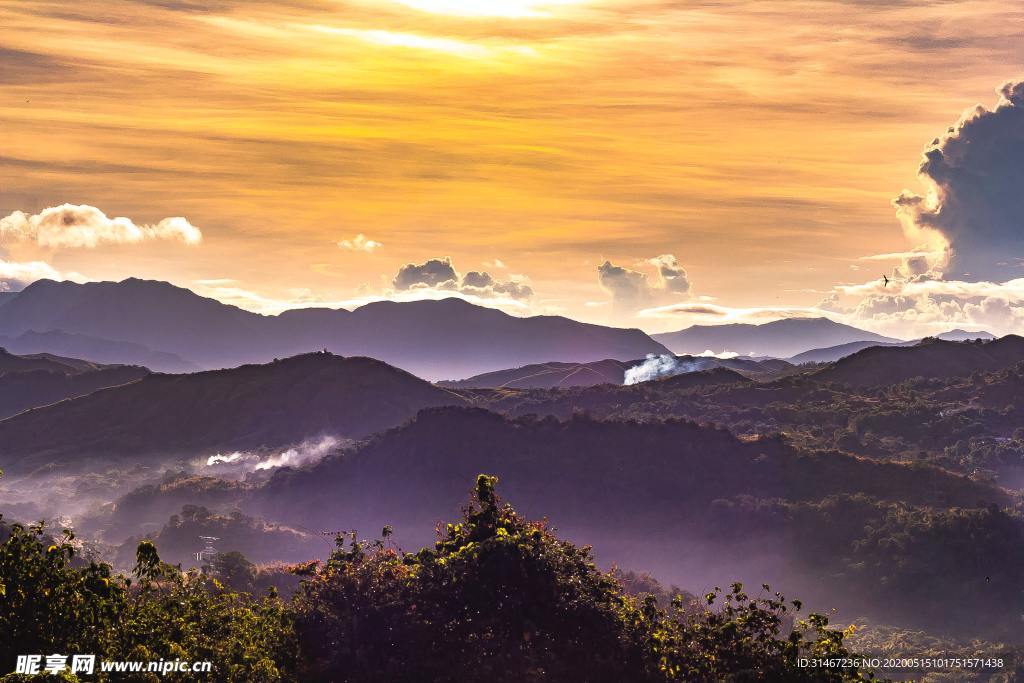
[9, 279, 990, 376]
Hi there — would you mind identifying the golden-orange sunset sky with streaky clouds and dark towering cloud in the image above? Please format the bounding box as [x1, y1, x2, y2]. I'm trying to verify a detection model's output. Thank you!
[0, 0, 1024, 338]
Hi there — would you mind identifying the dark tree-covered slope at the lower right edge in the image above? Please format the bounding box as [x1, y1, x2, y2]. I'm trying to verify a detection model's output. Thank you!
[713, 493, 1024, 640]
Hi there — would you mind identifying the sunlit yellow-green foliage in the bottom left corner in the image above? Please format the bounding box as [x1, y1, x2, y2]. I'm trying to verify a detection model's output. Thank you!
[0, 524, 295, 683]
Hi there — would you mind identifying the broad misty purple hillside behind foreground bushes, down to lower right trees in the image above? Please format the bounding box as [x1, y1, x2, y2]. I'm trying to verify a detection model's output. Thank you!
[246, 405, 1024, 630]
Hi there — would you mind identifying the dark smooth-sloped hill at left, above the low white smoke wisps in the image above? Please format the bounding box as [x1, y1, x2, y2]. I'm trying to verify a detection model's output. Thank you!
[0, 353, 465, 470]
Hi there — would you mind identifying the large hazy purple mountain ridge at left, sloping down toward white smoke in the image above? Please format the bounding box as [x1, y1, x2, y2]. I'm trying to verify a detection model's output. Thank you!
[0, 279, 668, 379]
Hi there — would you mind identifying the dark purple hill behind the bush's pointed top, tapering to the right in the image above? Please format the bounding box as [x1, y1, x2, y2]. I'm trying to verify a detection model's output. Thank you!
[256, 408, 1009, 539]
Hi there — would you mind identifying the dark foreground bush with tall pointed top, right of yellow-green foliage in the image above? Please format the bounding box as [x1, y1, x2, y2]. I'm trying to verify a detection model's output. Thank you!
[294, 475, 872, 683]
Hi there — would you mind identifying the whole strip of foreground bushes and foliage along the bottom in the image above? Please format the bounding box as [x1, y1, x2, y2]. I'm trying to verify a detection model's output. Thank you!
[0, 475, 880, 683]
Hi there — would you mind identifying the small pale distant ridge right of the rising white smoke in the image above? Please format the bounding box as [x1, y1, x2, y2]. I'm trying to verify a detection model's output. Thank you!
[653, 317, 902, 358]
